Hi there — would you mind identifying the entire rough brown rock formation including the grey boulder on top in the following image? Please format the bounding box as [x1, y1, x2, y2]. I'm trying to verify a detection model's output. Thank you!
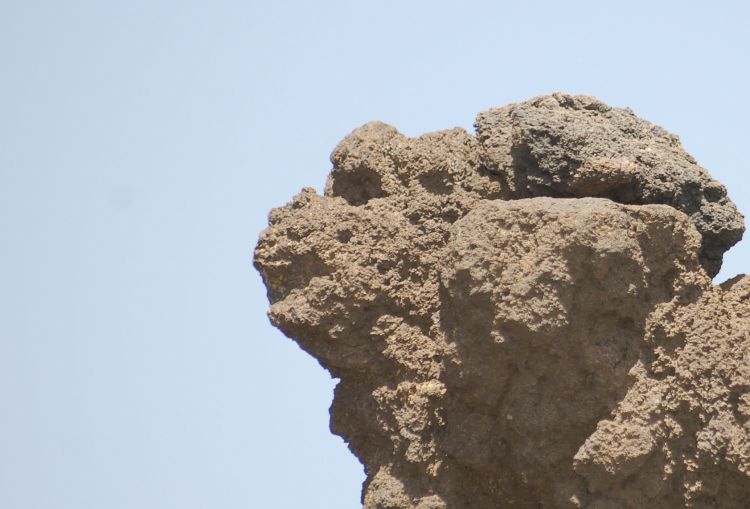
[255, 94, 750, 509]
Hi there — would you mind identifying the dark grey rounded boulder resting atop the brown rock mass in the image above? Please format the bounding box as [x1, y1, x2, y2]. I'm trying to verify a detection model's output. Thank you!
[476, 94, 745, 277]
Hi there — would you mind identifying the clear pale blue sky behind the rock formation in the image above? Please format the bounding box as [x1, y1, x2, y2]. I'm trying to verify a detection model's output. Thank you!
[0, 0, 750, 509]
